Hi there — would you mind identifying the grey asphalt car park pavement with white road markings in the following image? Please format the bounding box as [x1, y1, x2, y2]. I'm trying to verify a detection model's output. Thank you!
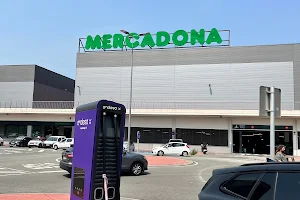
[0, 147, 255, 200]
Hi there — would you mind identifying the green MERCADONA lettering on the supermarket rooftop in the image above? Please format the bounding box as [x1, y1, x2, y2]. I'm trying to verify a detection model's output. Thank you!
[85, 28, 223, 50]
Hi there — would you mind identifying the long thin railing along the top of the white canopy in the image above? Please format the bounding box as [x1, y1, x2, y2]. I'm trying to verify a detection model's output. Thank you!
[0, 101, 300, 110]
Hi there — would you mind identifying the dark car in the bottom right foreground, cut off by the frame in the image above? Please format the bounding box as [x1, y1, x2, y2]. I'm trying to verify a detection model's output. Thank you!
[198, 162, 300, 200]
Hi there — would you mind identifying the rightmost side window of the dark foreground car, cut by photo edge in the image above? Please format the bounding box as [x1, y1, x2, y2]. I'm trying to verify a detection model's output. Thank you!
[275, 172, 300, 200]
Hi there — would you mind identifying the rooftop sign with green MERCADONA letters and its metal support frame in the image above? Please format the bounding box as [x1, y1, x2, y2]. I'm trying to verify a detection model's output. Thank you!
[79, 28, 230, 52]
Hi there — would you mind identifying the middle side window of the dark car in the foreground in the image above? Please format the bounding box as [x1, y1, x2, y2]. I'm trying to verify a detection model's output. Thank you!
[250, 173, 276, 200]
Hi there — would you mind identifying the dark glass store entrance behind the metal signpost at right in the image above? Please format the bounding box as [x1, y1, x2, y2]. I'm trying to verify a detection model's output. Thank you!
[233, 125, 293, 155]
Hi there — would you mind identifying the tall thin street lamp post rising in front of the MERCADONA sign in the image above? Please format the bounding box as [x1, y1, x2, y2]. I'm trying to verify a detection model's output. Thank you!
[120, 30, 149, 151]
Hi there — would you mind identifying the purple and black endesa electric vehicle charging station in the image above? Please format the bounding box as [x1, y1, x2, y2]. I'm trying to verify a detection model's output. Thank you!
[70, 100, 126, 200]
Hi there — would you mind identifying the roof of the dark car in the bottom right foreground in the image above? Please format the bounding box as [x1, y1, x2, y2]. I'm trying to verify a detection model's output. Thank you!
[213, 162, 300, 175]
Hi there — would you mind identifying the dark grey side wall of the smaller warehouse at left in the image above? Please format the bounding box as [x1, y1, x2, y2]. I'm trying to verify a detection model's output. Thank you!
[33, 66, 75, 101]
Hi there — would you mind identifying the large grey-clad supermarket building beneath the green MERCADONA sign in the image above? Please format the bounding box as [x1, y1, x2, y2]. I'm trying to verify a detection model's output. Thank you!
[0, 39, 300, 155]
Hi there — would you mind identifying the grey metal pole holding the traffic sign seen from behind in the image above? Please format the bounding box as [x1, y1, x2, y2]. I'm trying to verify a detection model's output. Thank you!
[270, 87, 275, 160]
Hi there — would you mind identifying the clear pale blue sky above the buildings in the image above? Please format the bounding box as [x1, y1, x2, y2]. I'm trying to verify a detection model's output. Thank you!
[0, 0, 300, 78]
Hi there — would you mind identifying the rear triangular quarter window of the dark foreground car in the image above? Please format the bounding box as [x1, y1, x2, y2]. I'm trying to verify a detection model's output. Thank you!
[223, 173, 261, 198]
